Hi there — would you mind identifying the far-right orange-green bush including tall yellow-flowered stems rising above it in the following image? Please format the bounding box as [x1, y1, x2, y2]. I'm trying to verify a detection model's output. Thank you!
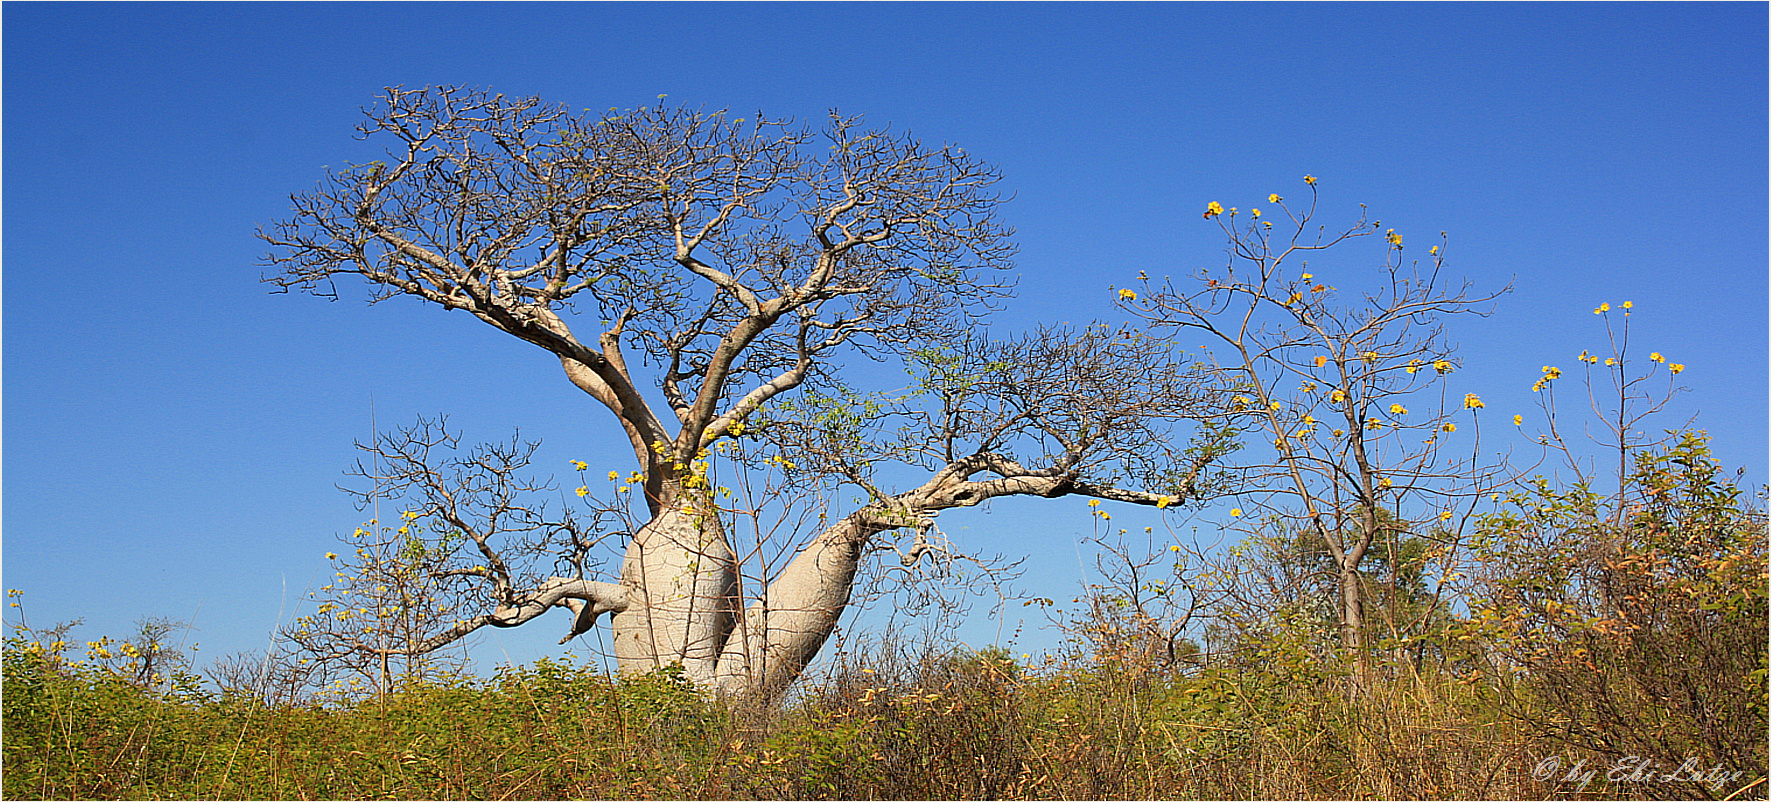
[1456, 301, 1771, 797]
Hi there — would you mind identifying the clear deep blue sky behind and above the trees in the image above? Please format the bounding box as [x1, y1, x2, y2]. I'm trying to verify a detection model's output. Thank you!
[0, 2, 1767, 660]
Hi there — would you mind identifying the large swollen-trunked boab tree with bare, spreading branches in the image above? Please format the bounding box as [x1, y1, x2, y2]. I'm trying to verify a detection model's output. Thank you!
[260, 89, 1218, 696]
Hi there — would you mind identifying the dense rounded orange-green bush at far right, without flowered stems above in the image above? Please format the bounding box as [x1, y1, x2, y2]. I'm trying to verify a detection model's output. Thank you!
[1468, 432, 1771, 797]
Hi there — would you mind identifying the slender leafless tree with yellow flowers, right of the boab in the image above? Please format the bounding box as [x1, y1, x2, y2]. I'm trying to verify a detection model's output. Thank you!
[1119, 177, 1496, 673]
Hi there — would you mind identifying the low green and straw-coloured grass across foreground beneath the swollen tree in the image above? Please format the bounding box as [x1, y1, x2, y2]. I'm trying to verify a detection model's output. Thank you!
[4, 641, 1764, 798]
